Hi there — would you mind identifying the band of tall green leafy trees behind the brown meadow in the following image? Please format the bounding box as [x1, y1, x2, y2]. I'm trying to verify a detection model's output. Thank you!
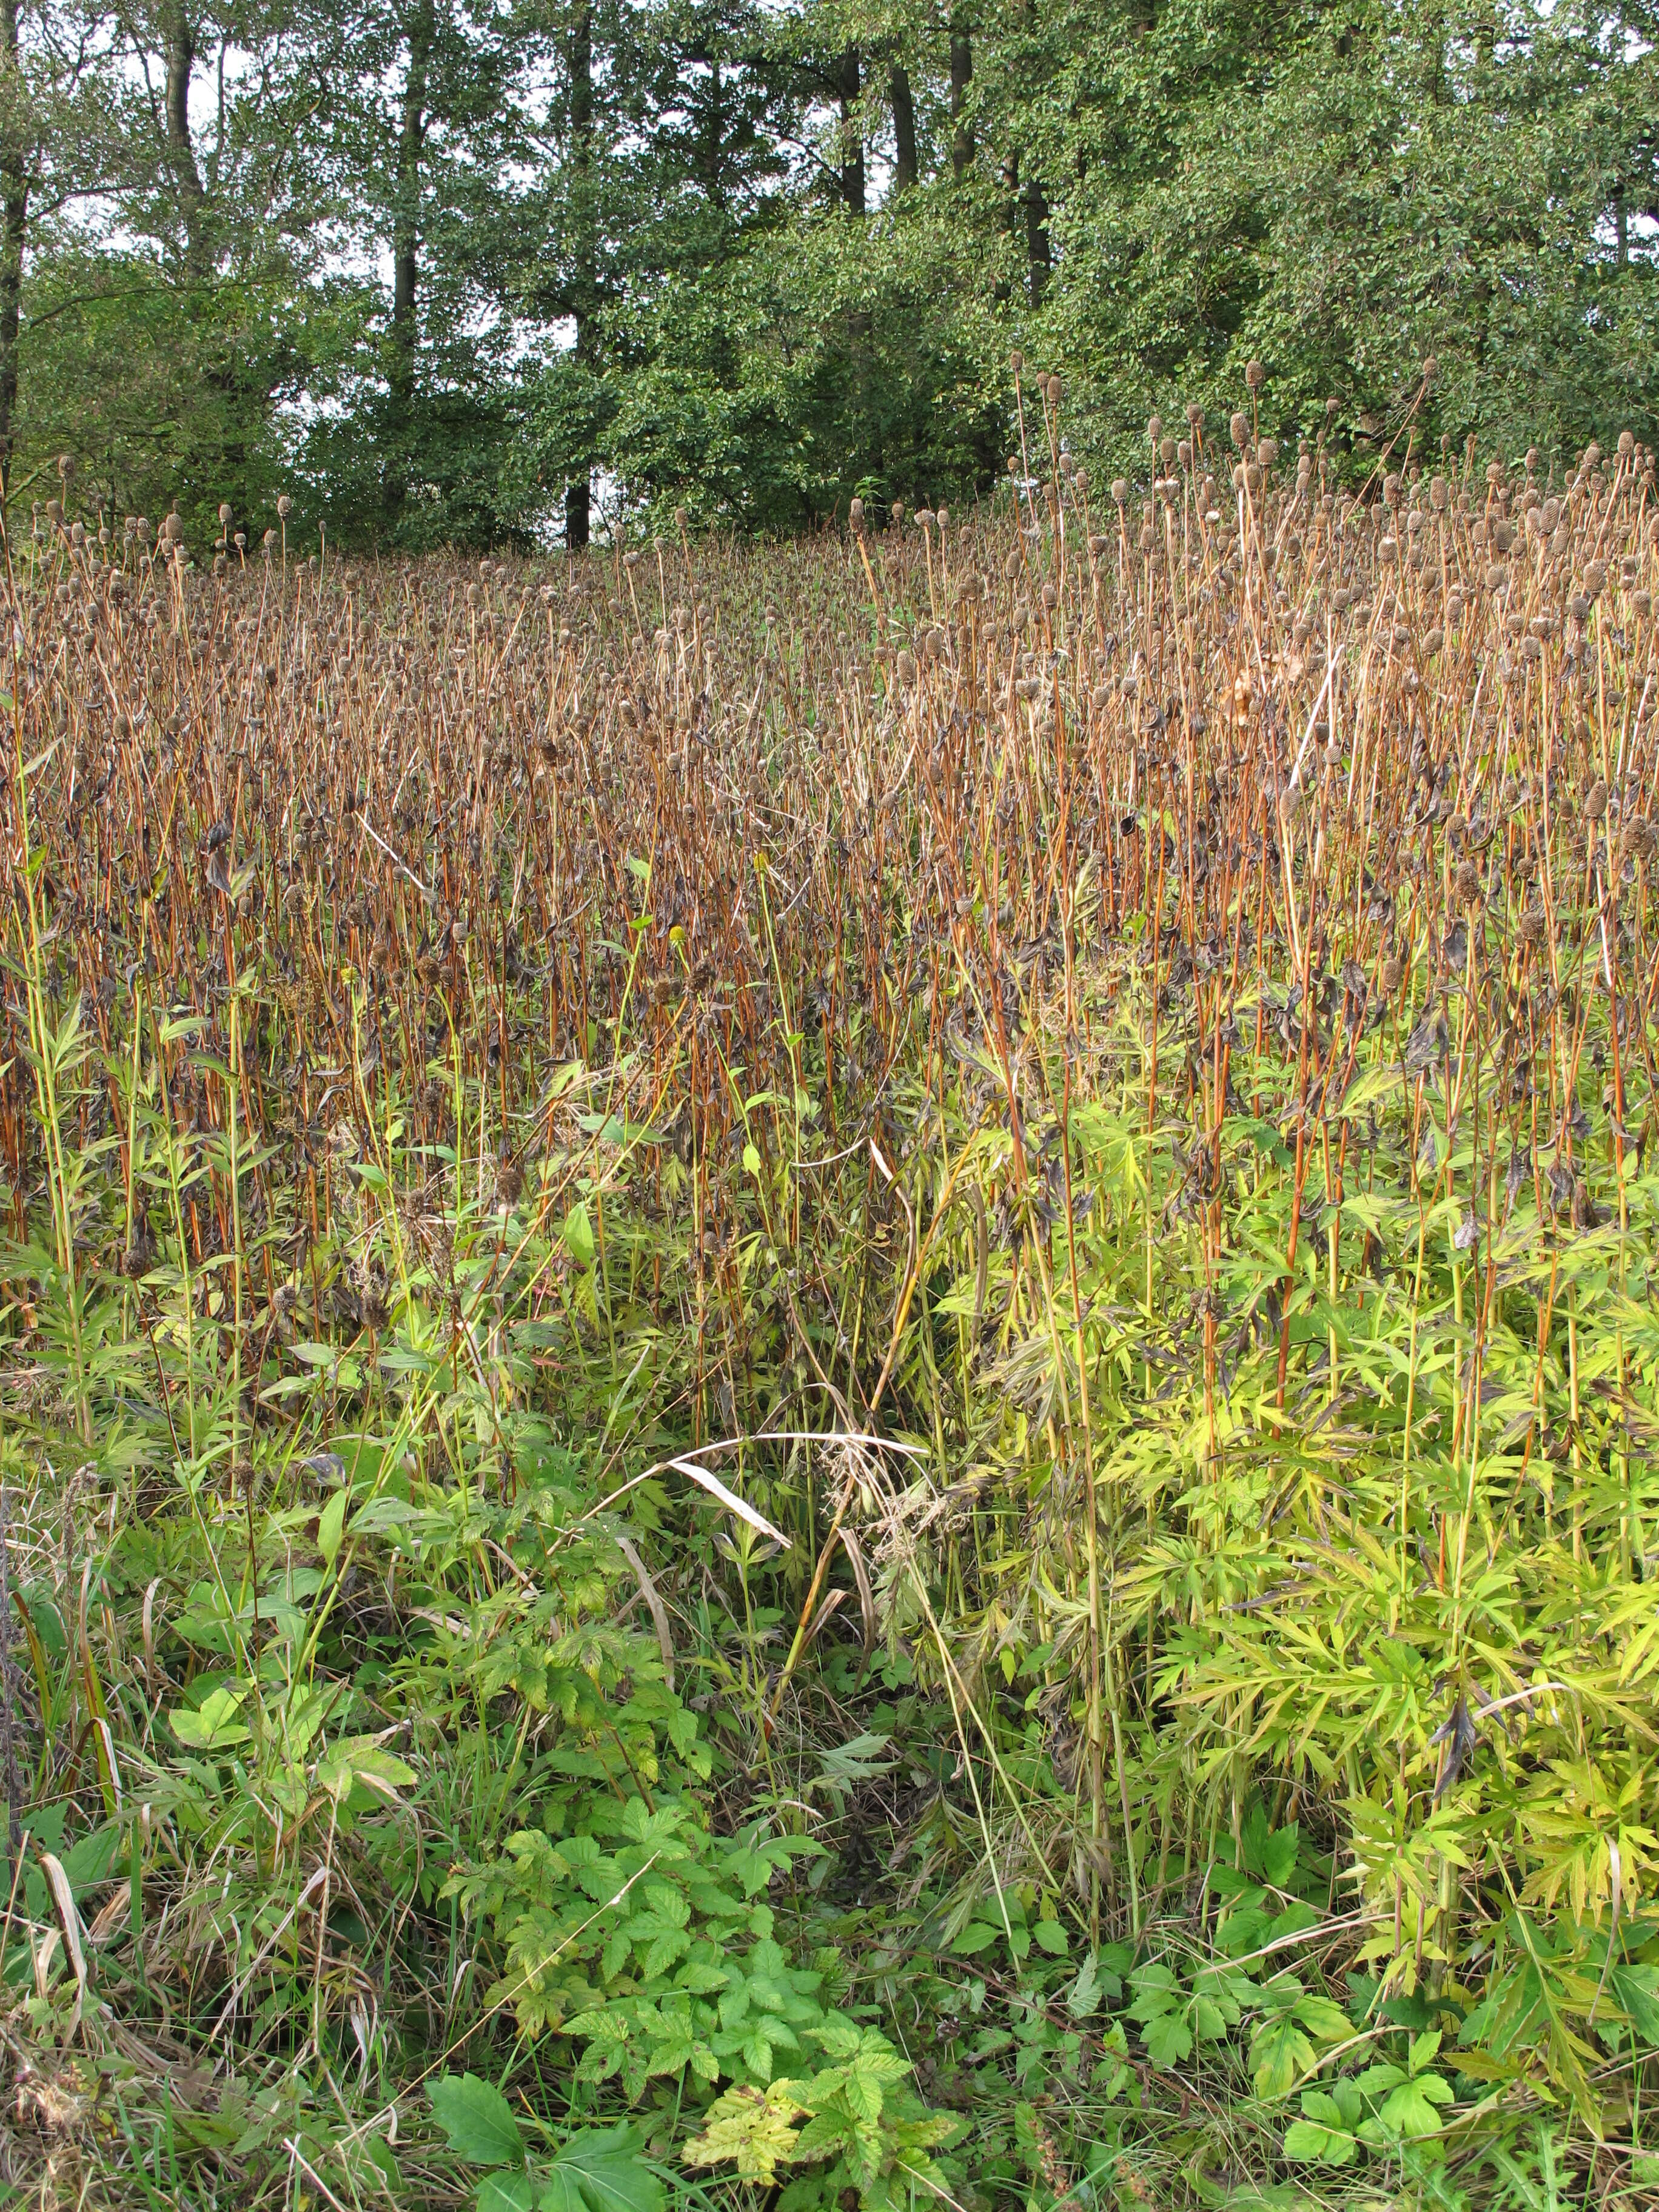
[0, 0, 1659, 551]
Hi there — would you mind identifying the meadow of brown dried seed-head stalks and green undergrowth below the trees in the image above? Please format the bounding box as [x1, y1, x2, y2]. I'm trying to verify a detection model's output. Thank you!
[0, 367, 1659, 2212]
